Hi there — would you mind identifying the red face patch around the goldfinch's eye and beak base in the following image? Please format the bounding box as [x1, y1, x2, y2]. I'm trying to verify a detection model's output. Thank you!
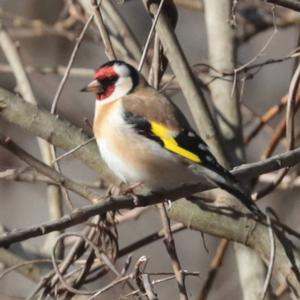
[94, 67, 119, 100]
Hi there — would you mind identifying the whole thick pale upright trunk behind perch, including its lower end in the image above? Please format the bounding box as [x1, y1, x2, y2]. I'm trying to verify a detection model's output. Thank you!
[204, 0, 265, 300]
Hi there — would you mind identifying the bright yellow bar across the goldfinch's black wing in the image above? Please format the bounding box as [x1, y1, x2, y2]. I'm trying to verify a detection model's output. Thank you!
[150, 122, 201, 163]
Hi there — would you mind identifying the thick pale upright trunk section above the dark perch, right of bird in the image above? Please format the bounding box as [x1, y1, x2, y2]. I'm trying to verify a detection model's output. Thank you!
[204, 0, 245, 167]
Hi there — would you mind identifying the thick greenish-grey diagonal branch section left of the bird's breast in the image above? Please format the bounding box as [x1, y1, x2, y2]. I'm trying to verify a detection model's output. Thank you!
[0, 88, 117, 182]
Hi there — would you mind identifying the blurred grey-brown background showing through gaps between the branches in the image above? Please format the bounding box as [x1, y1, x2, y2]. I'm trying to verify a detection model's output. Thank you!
[0, 0, 300, 300]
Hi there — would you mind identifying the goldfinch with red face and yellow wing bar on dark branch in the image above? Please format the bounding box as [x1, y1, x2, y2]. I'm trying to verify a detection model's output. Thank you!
[81, 60, 262, 215]
